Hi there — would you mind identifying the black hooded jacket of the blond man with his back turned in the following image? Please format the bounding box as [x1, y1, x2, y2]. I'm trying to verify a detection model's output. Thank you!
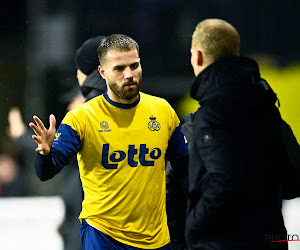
[186, 57, 287, 250]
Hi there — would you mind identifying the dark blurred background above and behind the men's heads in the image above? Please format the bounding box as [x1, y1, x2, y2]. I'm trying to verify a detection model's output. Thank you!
[0, 0, 300, 147]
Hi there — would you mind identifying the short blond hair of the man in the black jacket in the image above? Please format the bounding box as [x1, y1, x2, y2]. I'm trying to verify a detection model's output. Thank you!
[192, 19, 240, 62]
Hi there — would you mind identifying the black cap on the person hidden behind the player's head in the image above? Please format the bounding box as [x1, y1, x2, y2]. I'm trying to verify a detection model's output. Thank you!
[74, 36, 105, 75]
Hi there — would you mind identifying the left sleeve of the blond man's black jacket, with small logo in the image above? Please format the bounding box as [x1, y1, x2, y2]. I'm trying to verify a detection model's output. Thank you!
[186, 113, 245, 237]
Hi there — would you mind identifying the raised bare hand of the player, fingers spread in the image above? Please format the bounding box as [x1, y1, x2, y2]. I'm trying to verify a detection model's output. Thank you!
[29, 115, 56, 155]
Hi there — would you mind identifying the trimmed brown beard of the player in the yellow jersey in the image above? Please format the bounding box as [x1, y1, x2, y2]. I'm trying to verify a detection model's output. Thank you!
[106, 77, 142, 101]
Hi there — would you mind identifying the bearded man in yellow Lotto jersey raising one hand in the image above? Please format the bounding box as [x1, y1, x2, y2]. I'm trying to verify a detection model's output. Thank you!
[29, 34, 188, 250]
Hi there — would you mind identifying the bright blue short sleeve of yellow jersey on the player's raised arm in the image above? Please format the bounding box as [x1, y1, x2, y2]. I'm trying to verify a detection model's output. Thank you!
[52, 123, 81, 162]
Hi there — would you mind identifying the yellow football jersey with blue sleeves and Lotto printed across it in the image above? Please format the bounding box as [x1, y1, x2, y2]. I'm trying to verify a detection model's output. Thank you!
[52, 93, 187, 249]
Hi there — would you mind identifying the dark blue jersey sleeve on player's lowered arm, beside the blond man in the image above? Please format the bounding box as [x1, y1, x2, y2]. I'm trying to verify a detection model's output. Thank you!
[166, 124, 189, 161]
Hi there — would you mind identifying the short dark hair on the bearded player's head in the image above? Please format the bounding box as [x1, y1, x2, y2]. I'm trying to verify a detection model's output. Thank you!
[97, 34, 139, 65]
